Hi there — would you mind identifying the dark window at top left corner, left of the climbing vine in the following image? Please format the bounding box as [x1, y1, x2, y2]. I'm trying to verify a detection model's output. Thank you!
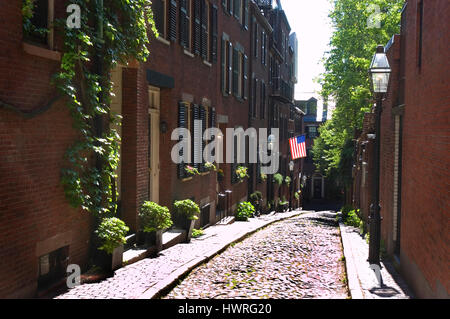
[23, 0, 54, 50]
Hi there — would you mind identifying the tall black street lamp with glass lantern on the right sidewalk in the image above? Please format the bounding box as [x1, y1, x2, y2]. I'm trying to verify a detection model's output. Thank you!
[368, 45, 391, 265]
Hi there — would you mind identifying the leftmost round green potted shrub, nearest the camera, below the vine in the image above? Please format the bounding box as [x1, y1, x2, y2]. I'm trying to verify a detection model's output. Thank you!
[95, 217, 130, 254]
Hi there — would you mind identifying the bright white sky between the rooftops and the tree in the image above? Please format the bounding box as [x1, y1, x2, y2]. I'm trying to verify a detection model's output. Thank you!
[280, 0, 332, 102]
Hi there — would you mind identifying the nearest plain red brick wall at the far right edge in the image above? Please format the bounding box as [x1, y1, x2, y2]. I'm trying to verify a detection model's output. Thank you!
[401, 0, 450, 298]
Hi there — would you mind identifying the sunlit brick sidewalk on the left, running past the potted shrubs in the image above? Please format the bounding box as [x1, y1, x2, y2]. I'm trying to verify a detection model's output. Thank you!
[55, 211, 305, 299]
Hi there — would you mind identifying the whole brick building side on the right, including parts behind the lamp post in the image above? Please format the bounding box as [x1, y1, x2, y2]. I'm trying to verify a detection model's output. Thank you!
[355, 0, 450, 298]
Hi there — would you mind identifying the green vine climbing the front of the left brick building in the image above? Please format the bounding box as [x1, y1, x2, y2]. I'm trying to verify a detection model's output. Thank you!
[53, 0, 157, 218]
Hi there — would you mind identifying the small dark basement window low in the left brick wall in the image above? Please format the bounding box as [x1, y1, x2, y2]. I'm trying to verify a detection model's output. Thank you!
[38, 246, 69, 289]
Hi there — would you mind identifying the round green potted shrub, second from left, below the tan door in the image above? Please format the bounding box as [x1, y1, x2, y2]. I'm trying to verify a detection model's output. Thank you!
[139, 201, 173, 232]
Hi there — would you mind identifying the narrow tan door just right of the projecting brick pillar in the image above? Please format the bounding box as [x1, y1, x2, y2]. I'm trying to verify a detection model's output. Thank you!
[148, 86, 161, 203]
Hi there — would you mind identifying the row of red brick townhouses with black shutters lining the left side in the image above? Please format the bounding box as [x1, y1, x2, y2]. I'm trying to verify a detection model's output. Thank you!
[0, 0, 302, 297]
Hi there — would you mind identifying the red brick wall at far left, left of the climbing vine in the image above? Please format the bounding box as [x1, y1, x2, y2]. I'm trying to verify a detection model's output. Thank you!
[0, 0, 90, 298]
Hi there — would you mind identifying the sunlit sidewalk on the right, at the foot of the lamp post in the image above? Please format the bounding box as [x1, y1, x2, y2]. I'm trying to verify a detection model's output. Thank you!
[339, 222, 413, 299]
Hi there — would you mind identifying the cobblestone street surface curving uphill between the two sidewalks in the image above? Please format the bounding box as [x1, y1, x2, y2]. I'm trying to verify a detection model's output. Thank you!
[164, 212, 348, 299]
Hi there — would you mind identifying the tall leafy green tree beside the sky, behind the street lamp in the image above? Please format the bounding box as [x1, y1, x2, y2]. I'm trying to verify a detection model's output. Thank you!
[313, 0, 404, 186]
